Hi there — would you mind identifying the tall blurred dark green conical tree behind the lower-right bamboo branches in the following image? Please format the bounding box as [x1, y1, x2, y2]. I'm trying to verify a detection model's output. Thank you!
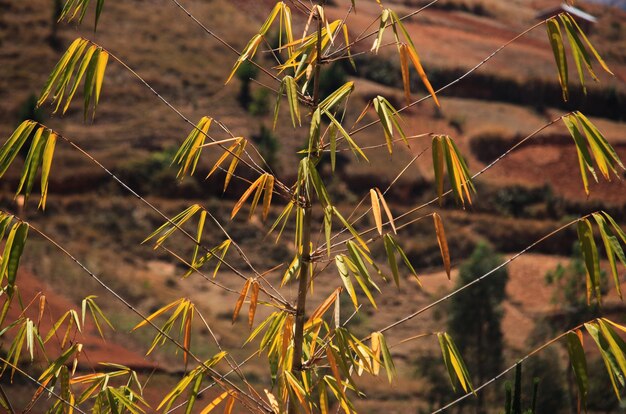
[448, 243, 508, 412]
